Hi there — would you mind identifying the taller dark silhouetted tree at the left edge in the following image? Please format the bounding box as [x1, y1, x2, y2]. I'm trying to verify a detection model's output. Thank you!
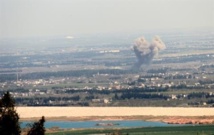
[0, 92, 21, 135]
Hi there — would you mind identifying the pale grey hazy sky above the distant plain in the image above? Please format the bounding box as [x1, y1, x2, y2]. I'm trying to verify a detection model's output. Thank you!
[0, 0, 214, 37]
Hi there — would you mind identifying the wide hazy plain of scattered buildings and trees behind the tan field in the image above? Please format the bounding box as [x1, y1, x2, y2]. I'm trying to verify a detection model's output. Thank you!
[0, 32, 214, 107]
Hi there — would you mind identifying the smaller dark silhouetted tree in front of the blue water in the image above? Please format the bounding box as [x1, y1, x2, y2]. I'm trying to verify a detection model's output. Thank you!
[27, 116, 45, 135]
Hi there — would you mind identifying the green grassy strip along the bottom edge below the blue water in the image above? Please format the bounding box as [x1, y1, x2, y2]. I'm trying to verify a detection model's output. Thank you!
[47, 125, 214, 135]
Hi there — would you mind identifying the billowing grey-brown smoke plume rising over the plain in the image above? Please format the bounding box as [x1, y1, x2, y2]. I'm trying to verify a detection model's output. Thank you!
[133, 36, 166, 68]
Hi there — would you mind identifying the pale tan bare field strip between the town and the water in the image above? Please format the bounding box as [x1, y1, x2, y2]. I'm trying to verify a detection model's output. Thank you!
[17, 107, 214, 119]
